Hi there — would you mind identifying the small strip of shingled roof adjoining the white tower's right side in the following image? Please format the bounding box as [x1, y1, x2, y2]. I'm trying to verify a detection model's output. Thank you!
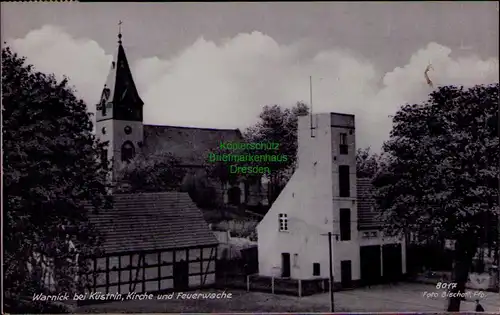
[357, 178, 381, 230]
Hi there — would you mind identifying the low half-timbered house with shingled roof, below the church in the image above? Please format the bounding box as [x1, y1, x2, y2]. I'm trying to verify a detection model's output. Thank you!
[86, 192, 218, 294]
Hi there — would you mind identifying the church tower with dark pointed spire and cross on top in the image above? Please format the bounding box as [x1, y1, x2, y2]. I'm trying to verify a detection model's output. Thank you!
[96, 26, 144, 179]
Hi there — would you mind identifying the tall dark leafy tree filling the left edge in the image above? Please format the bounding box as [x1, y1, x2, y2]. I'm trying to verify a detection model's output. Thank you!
[2, 48, 110, 313]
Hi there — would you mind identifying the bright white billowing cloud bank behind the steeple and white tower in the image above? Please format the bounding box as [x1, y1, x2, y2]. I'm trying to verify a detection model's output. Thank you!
[7, 26, 499, 149]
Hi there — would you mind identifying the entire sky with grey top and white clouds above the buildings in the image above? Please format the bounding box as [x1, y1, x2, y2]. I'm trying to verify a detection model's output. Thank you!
[1, 1, 499, 151]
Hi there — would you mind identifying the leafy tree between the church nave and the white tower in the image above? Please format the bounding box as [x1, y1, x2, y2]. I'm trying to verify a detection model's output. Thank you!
[244, 102, 309, 204]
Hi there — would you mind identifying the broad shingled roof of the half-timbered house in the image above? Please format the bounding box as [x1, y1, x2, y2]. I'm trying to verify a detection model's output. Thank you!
[90, 192, 218, 253]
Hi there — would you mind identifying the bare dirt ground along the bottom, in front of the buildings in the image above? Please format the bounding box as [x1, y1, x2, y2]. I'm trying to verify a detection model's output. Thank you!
[77, 283, 500, 314]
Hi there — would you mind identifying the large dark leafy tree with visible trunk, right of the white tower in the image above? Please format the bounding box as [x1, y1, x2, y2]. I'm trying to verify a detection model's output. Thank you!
[374, 83, 499, 311]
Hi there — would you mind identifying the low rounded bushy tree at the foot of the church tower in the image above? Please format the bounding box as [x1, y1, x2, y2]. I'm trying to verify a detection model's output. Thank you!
[117, 151, 186, 193]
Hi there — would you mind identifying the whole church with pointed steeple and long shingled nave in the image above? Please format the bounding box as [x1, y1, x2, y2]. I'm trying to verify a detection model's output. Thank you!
[96, 32, 267, 206]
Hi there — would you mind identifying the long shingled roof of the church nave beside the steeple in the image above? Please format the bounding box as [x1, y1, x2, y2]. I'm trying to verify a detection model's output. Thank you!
[143, 125, 243, 166]
